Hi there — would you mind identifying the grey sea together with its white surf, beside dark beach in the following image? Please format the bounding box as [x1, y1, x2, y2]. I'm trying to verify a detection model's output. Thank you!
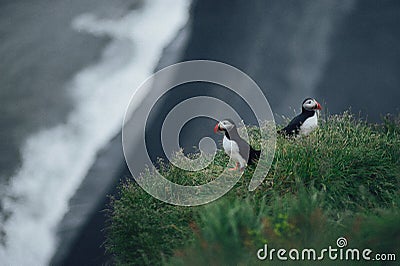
[0, 0, 188, 265]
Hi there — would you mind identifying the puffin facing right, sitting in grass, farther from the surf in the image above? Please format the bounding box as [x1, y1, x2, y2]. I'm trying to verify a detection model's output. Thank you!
[278, 98, 322, 136]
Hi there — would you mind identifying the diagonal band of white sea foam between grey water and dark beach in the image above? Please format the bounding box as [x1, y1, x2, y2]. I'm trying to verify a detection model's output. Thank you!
[0, 0, 190, 265]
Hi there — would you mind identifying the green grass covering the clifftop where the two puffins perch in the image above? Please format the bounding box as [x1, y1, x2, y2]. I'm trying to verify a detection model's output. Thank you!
[106, 113, 400, 265]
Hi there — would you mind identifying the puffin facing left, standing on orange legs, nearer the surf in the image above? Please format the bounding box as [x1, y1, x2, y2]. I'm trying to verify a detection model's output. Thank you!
[214, 119, 261, 171]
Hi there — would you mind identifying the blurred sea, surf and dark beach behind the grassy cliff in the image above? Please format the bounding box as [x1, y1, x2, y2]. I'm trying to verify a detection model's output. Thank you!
[0, 0, 400, 265]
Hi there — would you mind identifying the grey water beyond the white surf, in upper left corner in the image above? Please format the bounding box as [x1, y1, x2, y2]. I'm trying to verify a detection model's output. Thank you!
[0, 0, 111, 179]
